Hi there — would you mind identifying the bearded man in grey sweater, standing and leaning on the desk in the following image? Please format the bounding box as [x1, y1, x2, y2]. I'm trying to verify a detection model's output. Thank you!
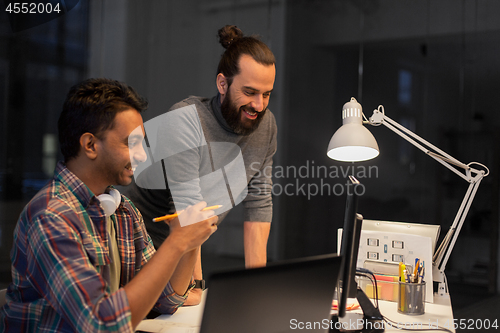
[122, 26, 277, 300]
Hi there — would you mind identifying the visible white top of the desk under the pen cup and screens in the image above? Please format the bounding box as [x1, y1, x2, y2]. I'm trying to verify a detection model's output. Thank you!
[137, 292, 455, 333]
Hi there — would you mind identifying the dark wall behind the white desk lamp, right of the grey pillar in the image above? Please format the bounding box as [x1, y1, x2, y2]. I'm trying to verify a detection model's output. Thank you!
[280, 1, 500, 288]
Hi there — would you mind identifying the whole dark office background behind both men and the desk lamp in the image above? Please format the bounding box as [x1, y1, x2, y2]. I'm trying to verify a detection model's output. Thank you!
[0, 0, 500, 322]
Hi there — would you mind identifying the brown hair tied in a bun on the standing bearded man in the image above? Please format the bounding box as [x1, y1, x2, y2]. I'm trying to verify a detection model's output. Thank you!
[217, 25, 276, 85]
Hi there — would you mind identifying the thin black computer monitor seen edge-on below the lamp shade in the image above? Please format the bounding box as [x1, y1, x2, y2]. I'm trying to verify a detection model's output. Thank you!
[337, 176, 383, 332]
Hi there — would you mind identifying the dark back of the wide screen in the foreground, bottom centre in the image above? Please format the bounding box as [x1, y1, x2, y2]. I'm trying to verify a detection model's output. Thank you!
[200, 254, 341, 333]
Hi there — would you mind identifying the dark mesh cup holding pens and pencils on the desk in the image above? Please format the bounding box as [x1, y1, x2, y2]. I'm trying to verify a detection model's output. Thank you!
[398, 282, 425, 315]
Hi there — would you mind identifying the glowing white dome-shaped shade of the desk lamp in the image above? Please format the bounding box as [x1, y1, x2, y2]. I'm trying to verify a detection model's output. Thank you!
[326, 123, 379, 162]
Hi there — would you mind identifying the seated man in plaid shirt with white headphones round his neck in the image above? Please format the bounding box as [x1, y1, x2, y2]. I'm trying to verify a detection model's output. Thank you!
[0, 79, 217, 332]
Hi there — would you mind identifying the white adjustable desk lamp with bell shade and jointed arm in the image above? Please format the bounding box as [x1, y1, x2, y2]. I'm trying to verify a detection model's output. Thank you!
[327, 97, 489, 296]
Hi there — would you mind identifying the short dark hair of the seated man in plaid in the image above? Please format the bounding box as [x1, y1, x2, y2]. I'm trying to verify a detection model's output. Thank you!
[57, 78, 148, 162]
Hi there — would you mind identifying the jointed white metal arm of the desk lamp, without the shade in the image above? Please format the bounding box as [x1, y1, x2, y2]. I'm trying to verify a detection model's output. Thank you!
[369, 105, 489, 295]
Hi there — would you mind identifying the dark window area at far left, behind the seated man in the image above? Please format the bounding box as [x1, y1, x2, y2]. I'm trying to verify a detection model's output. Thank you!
[0, 0, 89, 286]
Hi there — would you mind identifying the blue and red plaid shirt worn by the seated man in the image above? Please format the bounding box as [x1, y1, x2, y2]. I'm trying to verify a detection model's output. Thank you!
[0, 162, 185, 332]
